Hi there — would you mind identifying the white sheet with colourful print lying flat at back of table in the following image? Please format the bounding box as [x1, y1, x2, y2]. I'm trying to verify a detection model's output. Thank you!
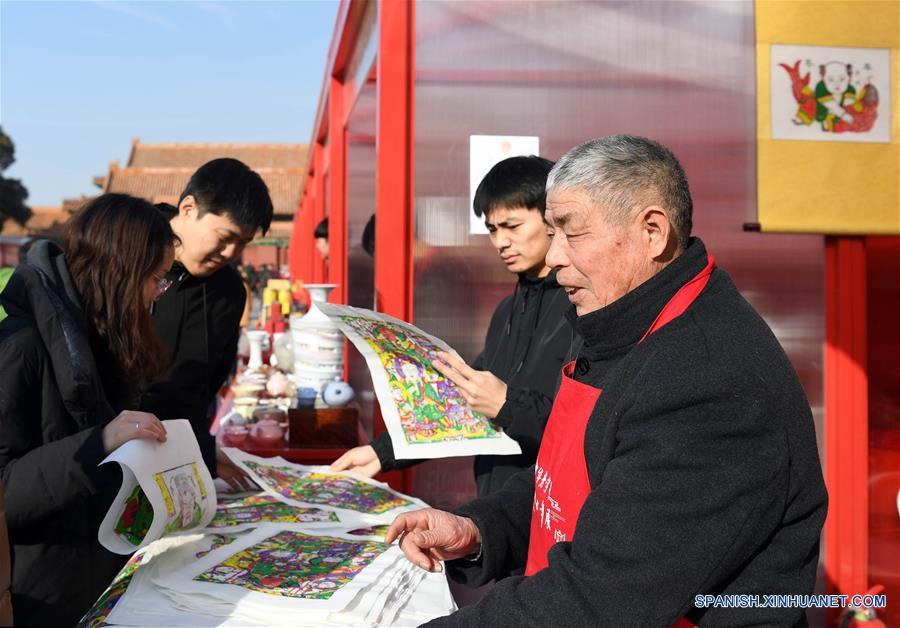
[222, 447, 428, 526]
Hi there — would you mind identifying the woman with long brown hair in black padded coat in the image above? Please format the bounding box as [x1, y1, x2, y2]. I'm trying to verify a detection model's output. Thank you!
[0, 194, 176, 626]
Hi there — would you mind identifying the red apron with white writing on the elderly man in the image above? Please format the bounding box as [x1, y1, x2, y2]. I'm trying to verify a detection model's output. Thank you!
[525, 255, 716, 626]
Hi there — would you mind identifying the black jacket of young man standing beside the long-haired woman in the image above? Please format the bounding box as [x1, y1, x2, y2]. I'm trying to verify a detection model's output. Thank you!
[141, 262, 246, 477]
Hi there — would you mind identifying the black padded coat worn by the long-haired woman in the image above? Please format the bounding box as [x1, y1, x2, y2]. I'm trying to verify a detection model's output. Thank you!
[0, 241, 127, 626]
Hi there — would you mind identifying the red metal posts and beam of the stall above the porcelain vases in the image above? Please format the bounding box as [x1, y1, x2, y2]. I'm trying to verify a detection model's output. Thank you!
[289, 0, 414, 491]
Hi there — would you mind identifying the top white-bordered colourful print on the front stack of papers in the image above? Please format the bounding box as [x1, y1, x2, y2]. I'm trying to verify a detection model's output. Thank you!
[154, 524, 424, 625]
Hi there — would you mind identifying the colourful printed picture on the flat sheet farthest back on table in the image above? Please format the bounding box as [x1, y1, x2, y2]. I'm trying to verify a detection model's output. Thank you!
[243, 460, 412, 515]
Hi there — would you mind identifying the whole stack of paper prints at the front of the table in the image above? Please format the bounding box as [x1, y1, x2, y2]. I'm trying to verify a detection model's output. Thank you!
[80, 524, 456, 628]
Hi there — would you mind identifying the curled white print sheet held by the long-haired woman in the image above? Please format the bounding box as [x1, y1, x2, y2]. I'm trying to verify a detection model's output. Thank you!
[97, 419, 216, 554]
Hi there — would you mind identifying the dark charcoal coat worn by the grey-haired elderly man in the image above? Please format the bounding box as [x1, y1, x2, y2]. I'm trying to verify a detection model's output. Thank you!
[440, 239, 827, 628]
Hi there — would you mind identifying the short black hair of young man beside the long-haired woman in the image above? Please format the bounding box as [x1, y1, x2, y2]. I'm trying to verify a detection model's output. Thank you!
[178, 157, 274, 234]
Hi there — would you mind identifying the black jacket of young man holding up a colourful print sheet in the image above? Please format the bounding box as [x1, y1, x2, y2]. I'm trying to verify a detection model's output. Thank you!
[372, 272, 572, 496]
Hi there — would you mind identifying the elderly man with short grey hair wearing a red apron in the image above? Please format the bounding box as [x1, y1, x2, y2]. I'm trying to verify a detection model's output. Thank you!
[388, 136, 826, 627]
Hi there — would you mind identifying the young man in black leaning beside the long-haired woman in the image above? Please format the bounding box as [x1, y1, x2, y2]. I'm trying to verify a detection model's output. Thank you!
[141, 158, 273, 485]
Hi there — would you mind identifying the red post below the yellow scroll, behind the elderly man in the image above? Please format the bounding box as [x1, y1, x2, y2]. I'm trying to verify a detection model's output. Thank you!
[824, 237, 869, 608]
